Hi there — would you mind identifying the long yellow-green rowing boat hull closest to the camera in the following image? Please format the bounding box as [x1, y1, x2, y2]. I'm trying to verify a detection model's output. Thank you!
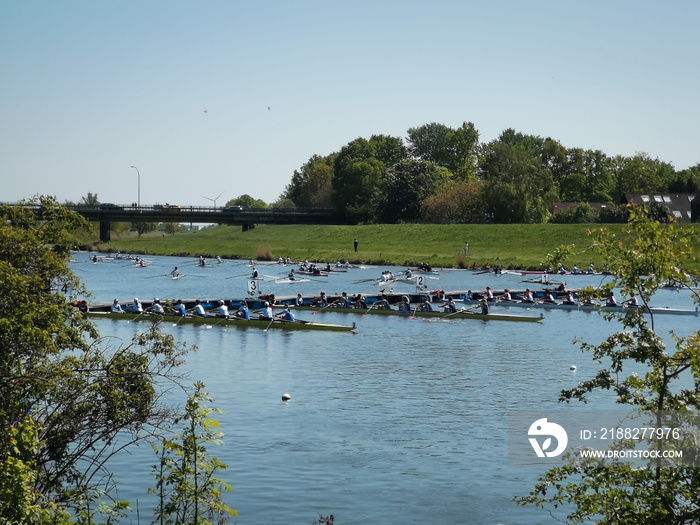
[87, 311, 355, 332]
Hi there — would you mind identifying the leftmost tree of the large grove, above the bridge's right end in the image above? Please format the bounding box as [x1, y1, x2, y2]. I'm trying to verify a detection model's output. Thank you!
[284, 154, 335, 208]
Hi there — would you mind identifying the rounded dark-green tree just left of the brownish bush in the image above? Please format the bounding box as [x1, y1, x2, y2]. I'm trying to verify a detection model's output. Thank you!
[377, 159, 452, 224]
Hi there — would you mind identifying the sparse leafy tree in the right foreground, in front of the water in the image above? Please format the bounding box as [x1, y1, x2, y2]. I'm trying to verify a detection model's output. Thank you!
[515, 207, 700, 525]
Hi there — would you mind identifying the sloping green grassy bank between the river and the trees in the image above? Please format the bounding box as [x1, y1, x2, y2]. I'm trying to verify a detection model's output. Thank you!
[87, 224, 652, 268]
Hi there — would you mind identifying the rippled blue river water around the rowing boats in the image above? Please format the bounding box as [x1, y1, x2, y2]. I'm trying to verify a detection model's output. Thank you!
[69, 253, 698, 524]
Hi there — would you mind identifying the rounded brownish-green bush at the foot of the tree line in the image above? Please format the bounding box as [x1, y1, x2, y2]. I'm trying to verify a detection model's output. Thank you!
[421, 180, 486, 224]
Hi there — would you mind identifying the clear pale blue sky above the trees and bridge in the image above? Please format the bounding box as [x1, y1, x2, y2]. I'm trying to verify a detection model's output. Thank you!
[0, 0, 700, 205]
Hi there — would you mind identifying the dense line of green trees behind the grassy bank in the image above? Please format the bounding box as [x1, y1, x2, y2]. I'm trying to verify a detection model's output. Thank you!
[275, 122, 700, 224]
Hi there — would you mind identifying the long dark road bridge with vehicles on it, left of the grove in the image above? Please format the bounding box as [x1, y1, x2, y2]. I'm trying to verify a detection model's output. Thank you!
[32, 203, 347, 242]
